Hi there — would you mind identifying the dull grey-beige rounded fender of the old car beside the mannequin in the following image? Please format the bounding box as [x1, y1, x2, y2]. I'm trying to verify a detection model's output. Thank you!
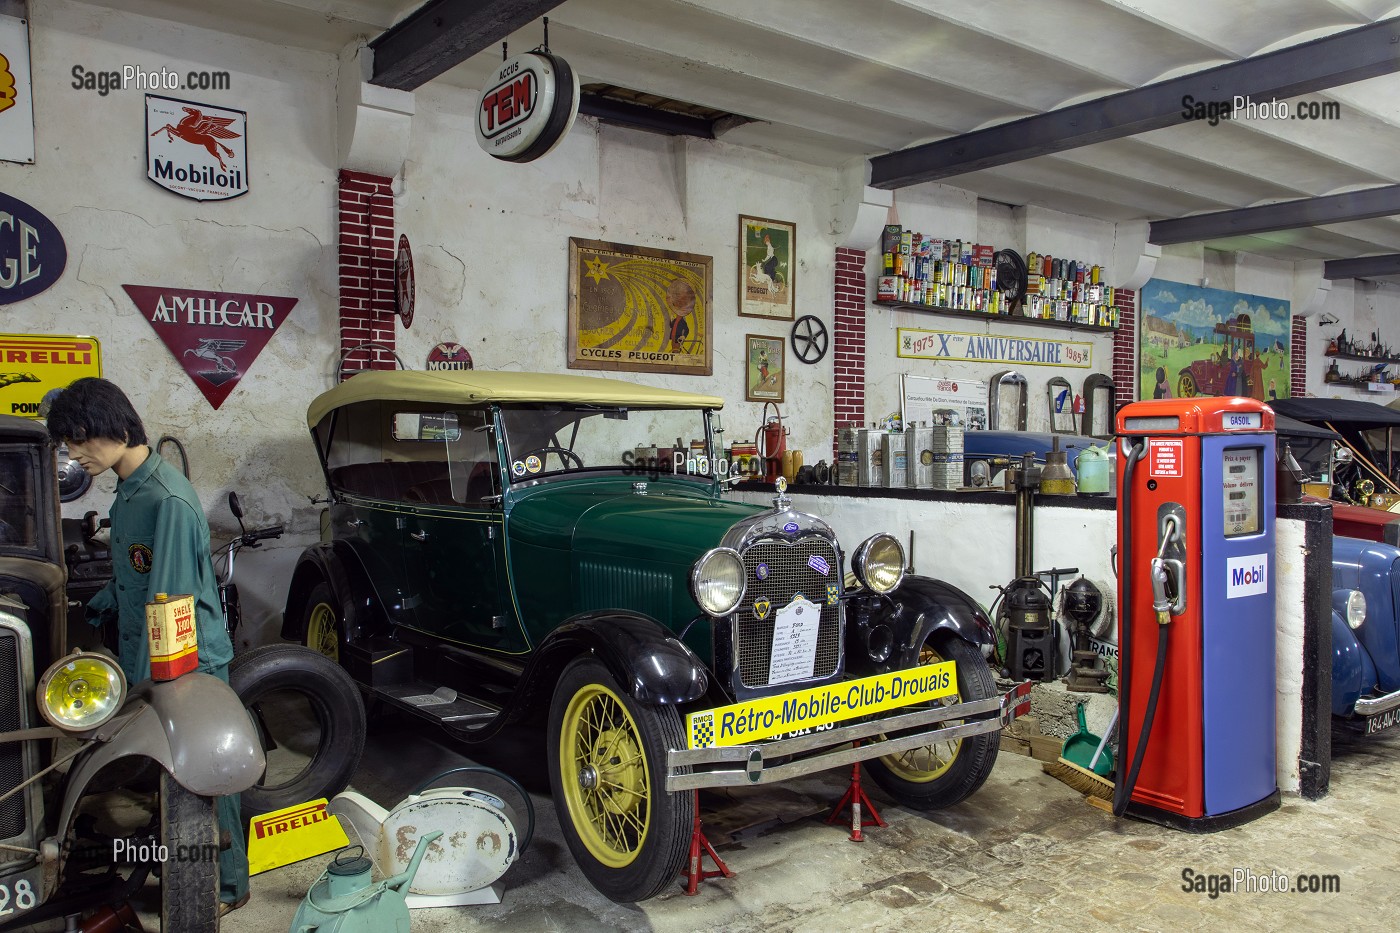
[59, 671, 267, 839]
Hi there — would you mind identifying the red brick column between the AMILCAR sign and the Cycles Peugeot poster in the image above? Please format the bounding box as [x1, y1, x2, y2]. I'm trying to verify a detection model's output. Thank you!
[340, 170, 395, 375]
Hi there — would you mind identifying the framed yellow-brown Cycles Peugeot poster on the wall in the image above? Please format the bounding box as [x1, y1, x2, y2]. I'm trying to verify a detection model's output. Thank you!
[567, 237, 714, 375]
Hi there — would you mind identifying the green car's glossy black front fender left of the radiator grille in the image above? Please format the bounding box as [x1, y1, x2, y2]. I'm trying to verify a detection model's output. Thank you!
[521, 609, 710, 709]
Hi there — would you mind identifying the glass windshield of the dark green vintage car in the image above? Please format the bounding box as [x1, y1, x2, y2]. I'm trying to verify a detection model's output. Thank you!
[501, 405, 715, 482]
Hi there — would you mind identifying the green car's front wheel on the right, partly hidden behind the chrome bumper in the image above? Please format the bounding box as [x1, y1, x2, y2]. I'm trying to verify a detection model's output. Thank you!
[865, 635, 1001, 810]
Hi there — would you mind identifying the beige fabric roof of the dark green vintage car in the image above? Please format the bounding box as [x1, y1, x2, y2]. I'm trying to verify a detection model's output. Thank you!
[307, 370, 724, 427]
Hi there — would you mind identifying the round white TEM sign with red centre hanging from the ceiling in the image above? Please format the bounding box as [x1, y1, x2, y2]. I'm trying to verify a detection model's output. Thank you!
[476, 52, 578, 163]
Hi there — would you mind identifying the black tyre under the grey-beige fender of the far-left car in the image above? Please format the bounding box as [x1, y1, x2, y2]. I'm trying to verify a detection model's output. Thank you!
[161, 770, 218, 933]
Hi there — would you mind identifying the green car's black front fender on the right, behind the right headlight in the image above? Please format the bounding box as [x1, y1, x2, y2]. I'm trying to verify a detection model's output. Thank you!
[847, 574, 995, 674]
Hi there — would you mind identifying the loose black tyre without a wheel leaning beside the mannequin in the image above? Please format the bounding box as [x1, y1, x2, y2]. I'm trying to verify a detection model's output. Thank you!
[228, 644, 365, 820]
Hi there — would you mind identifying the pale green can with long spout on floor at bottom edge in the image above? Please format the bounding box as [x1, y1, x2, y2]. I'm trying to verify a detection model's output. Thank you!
[291, 832, 442, 933]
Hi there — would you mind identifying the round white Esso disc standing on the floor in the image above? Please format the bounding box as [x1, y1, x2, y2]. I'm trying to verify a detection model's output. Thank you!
[378, 787, 519, 897]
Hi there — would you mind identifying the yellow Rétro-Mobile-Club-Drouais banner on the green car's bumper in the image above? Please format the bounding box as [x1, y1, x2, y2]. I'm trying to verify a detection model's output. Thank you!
[686, 661, 958, 748]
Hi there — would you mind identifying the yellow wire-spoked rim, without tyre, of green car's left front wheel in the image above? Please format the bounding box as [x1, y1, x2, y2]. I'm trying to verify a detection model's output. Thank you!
[559, 684, 651, 869]
